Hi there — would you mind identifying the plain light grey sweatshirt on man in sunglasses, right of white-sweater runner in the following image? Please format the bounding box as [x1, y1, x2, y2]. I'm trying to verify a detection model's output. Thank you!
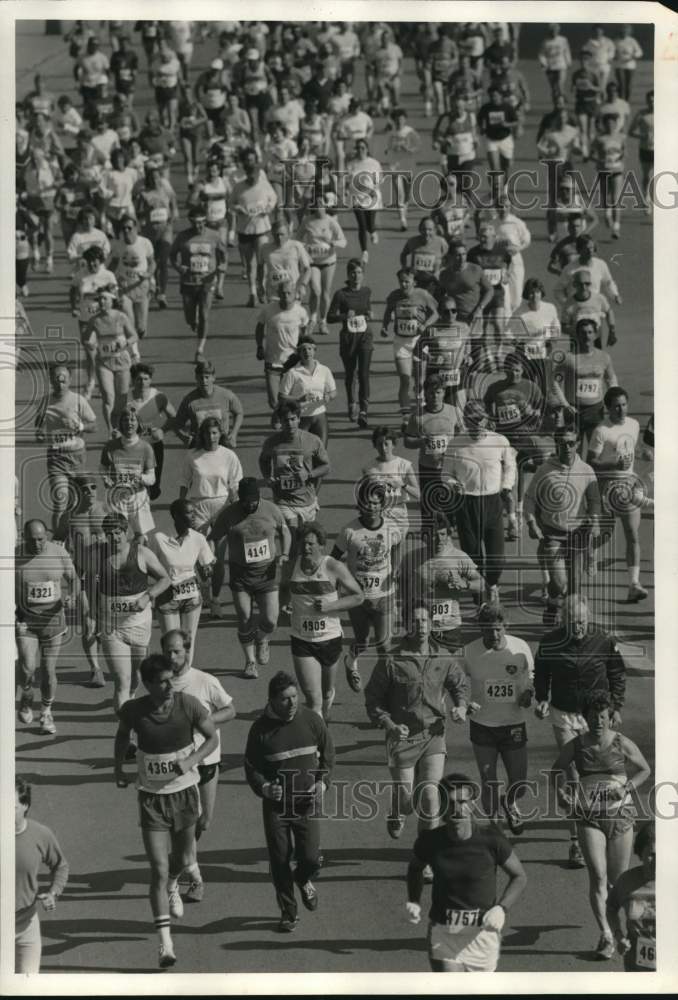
[525, 455, 601, 534]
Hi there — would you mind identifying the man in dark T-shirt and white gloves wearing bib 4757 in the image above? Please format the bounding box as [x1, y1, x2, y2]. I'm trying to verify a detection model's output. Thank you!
[406, 773, 527, 972]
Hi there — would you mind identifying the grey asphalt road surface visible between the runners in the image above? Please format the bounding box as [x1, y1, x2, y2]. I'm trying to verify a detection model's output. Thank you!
[16, 21, 654, 973]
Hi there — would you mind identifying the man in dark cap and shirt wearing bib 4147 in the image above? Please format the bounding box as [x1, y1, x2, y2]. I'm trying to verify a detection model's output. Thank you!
[209, 476, 292, 678]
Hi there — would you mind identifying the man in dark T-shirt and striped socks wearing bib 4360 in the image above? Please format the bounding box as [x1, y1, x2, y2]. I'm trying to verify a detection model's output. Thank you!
[115, 653, 218, 969]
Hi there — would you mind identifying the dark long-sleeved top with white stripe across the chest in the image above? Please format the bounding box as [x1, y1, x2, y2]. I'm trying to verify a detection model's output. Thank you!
[245, 706, 334, 811]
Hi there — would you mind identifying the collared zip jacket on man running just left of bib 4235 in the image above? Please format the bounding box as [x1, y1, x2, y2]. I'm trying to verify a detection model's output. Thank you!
[365, 639, 469, 736]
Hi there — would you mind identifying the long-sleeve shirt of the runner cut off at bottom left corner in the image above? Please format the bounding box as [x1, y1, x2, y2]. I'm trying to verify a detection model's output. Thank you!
[14, 819, 68, 932]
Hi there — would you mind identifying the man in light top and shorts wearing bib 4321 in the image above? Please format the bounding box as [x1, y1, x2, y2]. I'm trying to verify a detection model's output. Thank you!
[14, 519, 81, 736]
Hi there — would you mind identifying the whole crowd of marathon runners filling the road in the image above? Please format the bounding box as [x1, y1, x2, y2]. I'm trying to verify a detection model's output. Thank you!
[15, 21, 655, 972]
